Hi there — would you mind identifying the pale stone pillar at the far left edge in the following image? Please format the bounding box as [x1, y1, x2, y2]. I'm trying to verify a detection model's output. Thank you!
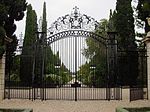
[0, 55, 5, 101]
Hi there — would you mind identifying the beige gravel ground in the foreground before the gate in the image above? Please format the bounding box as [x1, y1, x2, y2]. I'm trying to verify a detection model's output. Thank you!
[0, 99, 150, 112]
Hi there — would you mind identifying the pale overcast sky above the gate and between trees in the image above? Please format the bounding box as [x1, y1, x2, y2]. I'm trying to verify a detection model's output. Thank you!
[15, 0, 116, 36]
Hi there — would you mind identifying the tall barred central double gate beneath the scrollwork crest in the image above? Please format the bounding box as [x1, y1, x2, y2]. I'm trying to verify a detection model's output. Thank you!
[45, 30, 121, 100]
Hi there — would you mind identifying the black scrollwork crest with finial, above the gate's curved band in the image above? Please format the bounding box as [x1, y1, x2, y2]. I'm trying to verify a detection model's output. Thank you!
[48, 7, 99, 36]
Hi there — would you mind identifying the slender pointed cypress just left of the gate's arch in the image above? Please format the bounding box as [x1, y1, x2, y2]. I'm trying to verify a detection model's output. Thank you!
[34, 2, 47, 85]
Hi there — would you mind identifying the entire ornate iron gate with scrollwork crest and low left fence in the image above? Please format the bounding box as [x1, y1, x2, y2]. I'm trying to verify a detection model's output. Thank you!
[5, 7, 122, 101]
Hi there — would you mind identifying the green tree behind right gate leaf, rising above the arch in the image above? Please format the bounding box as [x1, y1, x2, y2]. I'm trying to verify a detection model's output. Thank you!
[78, 19, 108, 87]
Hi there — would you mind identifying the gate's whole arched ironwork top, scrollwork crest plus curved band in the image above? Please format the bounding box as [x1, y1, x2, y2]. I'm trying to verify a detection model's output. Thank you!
[47, 7, 107, 45]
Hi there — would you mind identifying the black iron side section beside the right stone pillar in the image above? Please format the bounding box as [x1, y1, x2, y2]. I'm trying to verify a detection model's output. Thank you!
[118, 46, 148, 101]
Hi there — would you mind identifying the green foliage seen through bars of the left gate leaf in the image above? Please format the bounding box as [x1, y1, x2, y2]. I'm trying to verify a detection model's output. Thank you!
[45, 47, 71, 86]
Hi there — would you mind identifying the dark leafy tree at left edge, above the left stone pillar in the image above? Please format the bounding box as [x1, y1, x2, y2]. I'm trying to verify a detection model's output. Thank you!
[0, 0, 27, 78]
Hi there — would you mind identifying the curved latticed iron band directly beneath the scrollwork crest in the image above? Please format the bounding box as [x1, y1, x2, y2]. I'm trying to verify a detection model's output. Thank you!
[47, 30, 107, 46]
